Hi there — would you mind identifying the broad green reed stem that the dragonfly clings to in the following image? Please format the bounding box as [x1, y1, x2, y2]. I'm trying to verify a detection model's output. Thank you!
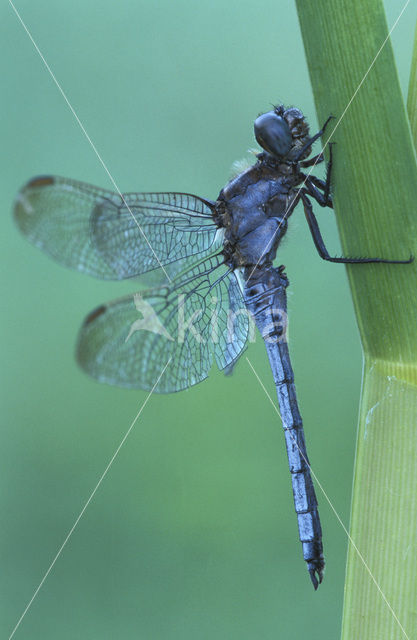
[296, 0, 417, 640]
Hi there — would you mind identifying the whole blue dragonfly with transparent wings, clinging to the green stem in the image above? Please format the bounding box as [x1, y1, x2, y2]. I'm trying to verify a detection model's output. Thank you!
[14, 105, 412, 589]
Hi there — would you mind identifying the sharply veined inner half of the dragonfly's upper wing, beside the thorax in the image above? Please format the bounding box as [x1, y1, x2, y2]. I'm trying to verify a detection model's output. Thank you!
[91, 193, 220, 278]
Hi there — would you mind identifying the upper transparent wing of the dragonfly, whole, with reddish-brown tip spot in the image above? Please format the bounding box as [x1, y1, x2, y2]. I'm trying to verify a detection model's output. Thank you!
[14, 176, 221, 280]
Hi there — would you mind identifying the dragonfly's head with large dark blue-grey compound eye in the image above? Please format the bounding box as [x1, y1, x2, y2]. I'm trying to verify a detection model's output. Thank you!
[254, 105, 310, 161]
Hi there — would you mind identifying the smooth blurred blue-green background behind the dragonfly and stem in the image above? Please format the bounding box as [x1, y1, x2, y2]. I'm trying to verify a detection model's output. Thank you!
[0, 0, 417, 640]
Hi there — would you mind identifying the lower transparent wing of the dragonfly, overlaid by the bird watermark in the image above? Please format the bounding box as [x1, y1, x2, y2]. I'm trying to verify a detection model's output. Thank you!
[77, 255, 249, 393]
